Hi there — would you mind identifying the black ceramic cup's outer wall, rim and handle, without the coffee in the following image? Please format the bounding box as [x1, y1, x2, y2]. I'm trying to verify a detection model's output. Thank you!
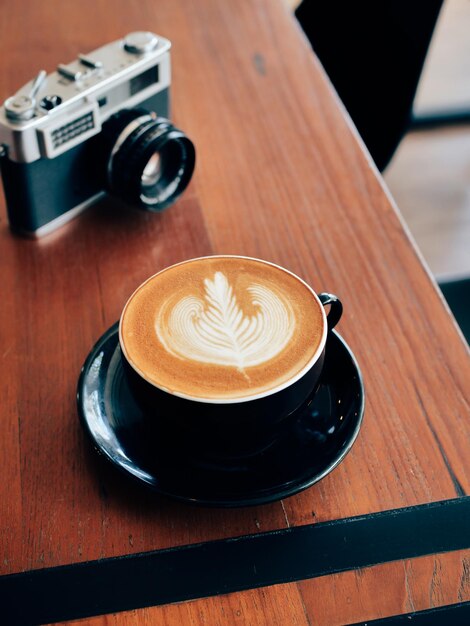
[119, 256, 343, 461]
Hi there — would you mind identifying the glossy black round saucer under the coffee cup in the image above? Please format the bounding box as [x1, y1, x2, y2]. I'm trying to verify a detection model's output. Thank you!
[77, 324, 364, 507]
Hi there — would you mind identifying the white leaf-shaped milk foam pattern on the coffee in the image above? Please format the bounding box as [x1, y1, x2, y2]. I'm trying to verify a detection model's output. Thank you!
[155, 272, 295, 372]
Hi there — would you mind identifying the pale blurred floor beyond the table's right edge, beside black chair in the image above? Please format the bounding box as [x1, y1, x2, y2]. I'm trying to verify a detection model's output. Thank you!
[384, 0, 470, 280]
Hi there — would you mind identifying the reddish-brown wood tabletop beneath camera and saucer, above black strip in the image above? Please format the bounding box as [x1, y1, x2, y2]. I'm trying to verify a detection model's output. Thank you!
[0, 0, 470, 624]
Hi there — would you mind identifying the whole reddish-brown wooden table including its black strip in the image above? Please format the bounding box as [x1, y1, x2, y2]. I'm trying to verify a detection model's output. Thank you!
[0, 0, 470, 626]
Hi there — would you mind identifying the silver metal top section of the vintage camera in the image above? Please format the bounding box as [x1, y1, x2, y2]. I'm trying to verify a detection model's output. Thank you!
[0, 32, 171, 163]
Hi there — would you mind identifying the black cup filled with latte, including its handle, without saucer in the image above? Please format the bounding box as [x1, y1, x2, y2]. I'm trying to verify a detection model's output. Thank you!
[119, 255, 342, 459]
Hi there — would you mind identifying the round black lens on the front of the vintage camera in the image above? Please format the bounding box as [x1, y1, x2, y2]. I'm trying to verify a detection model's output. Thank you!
[102, 109, 196, 211]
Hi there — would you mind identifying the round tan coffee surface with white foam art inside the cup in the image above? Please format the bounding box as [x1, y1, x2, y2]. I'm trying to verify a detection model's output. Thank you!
[120, 256, 326, 402]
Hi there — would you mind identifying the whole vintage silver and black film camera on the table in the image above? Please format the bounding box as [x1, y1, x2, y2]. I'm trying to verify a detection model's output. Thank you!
[0, 32, 194, 237]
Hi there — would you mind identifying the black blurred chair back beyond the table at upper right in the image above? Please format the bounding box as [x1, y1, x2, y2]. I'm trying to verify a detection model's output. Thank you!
[295, 0, 443, 171]
